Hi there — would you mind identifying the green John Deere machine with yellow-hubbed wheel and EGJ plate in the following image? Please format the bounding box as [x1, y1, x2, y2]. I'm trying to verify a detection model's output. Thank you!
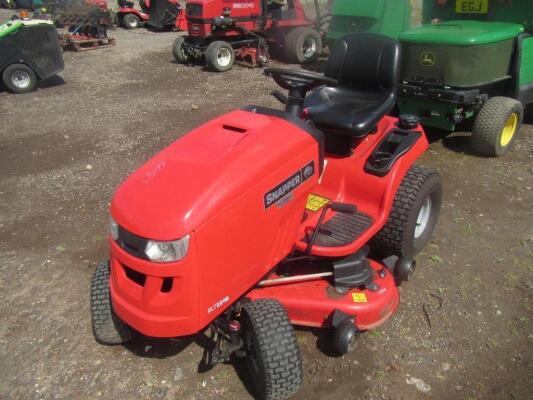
[398, 0, 533, 156]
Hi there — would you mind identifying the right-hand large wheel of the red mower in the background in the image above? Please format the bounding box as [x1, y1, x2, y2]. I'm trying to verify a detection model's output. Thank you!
[285, 27, 322, 64]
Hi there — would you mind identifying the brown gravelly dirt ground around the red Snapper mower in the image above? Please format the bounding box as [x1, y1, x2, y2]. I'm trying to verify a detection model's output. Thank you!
[0, 8, 533, 400]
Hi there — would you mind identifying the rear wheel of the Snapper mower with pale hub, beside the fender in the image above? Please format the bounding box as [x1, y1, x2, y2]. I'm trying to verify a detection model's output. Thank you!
[374, 165, 442, 257]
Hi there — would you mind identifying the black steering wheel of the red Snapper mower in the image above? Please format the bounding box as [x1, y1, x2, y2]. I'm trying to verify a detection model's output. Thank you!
[264, 68, 339, 96]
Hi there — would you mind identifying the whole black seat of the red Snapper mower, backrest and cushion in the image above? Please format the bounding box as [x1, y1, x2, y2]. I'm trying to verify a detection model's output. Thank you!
[305, 33, 400, 142]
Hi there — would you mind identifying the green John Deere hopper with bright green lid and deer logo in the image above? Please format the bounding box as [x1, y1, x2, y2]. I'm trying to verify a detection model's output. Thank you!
[400, 21, 524, 88]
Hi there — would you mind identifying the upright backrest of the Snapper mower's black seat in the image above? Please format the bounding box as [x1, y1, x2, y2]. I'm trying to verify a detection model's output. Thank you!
[325, 32, 401, 93]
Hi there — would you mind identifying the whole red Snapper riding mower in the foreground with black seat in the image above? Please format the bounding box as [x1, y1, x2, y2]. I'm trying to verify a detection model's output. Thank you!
[91, 33, 441, 399]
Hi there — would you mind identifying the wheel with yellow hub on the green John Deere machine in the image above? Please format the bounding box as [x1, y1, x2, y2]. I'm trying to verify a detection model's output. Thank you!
[472, 97, 524, 157]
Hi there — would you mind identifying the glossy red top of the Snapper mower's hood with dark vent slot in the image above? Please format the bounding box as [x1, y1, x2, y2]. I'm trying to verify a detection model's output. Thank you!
[111, 110, 313, 240]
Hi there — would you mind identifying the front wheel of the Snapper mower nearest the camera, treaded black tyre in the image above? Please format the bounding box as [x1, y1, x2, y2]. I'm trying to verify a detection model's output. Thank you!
[242, 299, 303, 400]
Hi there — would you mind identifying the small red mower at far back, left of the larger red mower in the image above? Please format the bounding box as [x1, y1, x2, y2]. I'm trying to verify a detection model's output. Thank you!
[117, 0, 187, 31]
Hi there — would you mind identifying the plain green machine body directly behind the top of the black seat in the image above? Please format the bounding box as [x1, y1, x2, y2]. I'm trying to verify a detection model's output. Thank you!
[327, 0, 411, 48]
